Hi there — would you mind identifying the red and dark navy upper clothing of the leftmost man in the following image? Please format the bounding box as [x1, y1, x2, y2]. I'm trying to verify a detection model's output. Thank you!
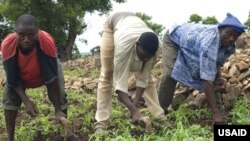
[1, 30, 58, 88]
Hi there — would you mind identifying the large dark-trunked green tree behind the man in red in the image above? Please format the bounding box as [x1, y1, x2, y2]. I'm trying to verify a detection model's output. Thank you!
[0, 0, 126, 60]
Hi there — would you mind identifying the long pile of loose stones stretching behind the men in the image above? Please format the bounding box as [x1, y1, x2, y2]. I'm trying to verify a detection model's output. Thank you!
[63, 38, 250, 109]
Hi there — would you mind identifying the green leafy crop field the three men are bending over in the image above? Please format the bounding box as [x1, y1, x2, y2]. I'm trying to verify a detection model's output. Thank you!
[0, 55, 250, 141]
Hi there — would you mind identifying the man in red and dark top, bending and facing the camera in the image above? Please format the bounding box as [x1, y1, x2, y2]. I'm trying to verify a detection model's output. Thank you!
[1, 14, 67, 141]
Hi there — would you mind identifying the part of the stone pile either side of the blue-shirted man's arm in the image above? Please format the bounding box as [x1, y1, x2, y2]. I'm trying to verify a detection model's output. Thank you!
[173, 49, 250, 111]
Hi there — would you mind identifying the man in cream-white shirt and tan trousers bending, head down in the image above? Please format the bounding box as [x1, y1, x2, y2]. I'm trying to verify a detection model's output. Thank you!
[95, 12, 169, 133]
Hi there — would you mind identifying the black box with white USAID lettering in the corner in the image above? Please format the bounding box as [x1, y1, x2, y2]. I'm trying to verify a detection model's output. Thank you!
[214, 125, 250, 141]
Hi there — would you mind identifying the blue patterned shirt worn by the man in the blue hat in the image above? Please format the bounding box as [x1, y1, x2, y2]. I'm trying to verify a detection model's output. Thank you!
[170, 23, 235, 90]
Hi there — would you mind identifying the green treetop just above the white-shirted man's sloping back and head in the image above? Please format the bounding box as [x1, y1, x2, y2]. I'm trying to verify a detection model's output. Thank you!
[136, 12, 165, 37]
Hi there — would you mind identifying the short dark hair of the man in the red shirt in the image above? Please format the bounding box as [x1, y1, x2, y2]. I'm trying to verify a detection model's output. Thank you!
[16, 14, 37, 29]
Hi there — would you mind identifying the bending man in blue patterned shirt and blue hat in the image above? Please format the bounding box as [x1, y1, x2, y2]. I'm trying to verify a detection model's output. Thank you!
[159, 13, 246, 124]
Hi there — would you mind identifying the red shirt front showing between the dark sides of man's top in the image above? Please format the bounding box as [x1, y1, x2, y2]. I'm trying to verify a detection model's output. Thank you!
[17, 48, 44, 88]
